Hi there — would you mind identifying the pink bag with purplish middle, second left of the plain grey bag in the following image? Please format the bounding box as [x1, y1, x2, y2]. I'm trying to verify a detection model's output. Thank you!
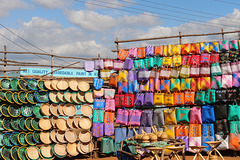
[128, 110, 142, 126]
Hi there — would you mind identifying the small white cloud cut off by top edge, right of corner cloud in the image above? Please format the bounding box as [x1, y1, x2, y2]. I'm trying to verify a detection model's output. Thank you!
[32, 0, 71, 9]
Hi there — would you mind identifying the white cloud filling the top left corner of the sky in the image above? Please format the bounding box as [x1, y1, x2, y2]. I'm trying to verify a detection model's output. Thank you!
[0, 0, 28, 17]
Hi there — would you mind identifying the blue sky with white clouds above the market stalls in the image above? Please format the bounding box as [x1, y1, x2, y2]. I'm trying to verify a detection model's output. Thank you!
[0, 0, 240, 63]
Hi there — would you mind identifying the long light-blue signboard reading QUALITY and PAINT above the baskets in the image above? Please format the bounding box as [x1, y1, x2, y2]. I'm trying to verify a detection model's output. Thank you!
[20, 67, 98, 78]
